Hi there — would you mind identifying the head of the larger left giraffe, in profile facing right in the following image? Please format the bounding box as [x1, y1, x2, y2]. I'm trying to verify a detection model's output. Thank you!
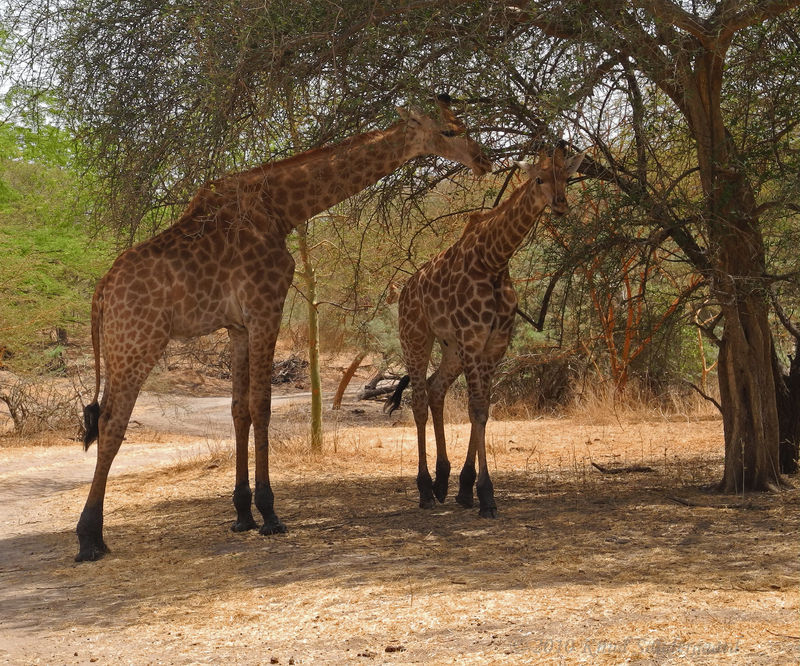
[397, 95, 492, 176]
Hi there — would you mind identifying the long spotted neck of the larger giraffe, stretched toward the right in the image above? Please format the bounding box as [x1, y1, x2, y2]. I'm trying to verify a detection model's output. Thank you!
[250, 122, 421, 233]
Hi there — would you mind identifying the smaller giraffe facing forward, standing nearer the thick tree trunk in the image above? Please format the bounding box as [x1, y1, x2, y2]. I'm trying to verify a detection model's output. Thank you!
[387, 147, 583, 518]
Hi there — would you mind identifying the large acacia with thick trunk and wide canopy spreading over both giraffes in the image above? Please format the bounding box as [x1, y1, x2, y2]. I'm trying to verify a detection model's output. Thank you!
[10, 0, 800, 491]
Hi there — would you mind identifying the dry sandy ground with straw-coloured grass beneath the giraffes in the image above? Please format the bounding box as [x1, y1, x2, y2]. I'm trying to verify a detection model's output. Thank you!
[0, 386, 800, 664]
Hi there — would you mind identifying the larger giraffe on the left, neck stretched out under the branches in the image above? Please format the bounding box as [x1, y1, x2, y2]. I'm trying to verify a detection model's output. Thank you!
[75, 95, 491, 562]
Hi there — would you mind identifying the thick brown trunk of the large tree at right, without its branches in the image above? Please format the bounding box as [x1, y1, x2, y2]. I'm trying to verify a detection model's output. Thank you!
[683, 50, 782, 493]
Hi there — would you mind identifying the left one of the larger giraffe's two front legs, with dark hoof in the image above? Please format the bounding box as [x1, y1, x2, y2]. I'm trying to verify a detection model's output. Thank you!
[228, 328, 258, 532]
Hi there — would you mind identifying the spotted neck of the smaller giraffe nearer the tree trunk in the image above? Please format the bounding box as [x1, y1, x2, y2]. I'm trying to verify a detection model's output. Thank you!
[477, 180, 546, 271]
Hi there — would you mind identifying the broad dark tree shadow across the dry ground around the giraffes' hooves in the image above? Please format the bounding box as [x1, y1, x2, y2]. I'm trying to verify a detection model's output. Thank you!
[0, 462, 800, 630]
